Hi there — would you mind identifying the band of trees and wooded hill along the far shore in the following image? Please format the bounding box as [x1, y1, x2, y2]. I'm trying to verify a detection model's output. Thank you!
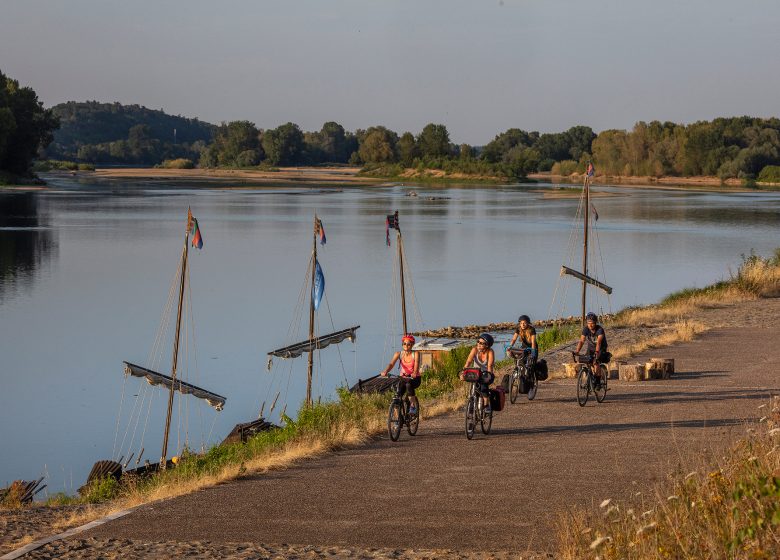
[0, 66, 780, 180]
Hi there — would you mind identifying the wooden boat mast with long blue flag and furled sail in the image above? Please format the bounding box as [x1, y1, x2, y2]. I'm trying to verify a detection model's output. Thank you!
[268, 213, 360, 408]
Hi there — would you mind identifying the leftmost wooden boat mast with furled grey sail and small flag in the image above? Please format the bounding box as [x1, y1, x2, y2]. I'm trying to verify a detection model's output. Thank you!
[124, 208, 225, 469]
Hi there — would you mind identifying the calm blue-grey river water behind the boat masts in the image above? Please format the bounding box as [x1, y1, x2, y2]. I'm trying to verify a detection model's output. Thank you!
[0, 178, 780, 492]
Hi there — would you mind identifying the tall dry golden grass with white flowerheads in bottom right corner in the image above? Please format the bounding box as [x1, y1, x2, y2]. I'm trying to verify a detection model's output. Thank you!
[559, 397, 780, 560]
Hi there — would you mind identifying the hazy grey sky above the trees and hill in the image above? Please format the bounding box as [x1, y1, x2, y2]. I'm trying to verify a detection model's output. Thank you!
[0, 0, 780, 144]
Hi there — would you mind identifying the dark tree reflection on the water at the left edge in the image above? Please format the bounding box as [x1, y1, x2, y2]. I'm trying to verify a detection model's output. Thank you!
[0, 192, 57, 300]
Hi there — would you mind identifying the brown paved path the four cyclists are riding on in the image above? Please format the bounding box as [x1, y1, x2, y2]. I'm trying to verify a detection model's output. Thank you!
[80, 300, 780, 552]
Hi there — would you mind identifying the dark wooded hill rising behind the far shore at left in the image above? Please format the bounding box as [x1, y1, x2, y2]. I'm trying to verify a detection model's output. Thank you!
[45, 101, 216, 164]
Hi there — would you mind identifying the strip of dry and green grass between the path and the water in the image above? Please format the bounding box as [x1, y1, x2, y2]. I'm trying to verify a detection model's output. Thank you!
[0, 255, 780, 552]
